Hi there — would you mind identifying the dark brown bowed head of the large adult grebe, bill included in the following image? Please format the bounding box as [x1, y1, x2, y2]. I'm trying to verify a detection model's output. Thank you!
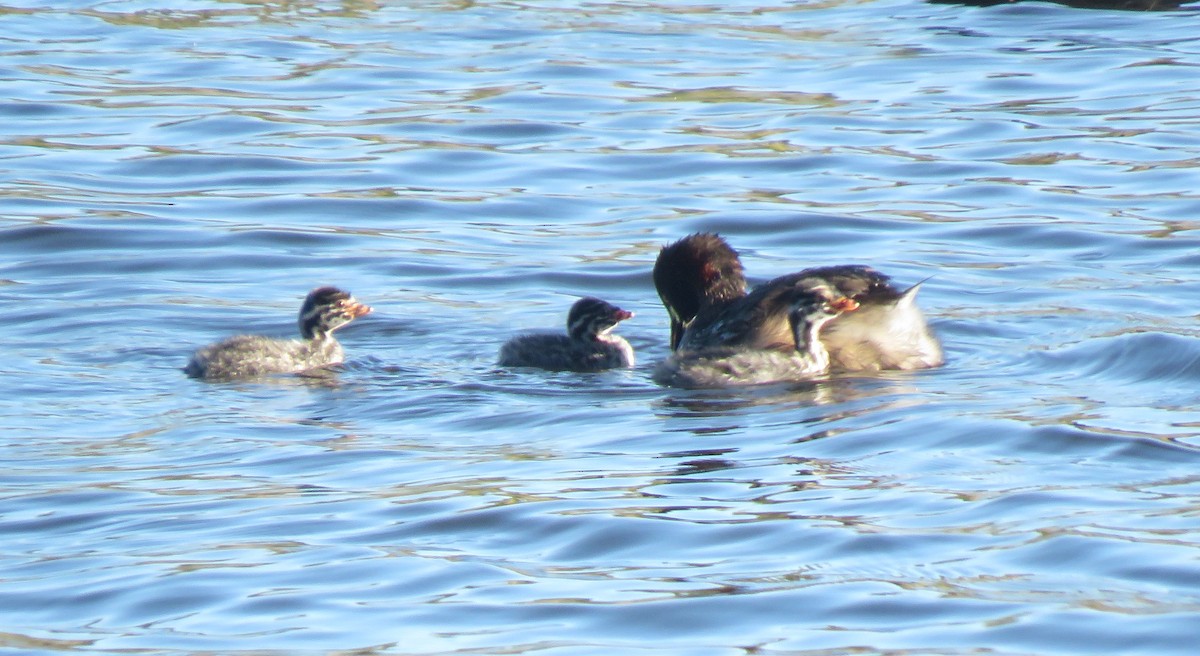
[654, 233, 746, 350]
